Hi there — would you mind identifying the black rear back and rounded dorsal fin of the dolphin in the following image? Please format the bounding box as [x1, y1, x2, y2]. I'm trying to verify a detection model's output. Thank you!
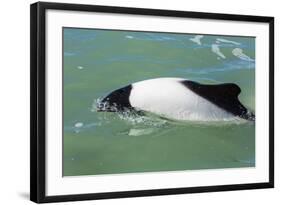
[181, 80, 254, 119]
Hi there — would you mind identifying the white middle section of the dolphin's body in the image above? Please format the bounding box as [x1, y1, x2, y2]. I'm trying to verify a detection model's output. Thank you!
[129, 78, 234, 121]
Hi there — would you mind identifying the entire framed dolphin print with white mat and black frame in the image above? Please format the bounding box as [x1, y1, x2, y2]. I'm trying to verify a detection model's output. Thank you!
[30, 2, 274, 203]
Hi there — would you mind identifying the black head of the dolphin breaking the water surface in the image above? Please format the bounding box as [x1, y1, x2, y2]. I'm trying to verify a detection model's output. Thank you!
[97, 85, 133, 112]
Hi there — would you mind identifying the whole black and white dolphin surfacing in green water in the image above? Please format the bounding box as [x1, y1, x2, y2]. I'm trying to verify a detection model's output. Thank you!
[97, 78, 255, 121]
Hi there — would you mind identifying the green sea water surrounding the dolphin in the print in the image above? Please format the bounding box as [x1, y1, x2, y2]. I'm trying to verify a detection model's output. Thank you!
[63, 28, 255, 176]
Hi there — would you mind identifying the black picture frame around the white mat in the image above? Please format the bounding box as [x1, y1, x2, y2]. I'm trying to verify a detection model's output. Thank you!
[30, 2, 274, 203]
